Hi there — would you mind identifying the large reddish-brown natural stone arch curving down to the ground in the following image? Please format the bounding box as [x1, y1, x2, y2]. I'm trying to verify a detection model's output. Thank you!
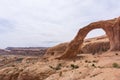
[59, 17, 120, 59]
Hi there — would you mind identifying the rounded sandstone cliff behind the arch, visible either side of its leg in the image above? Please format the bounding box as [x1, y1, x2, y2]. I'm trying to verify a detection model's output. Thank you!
[44, 35, 110, 57]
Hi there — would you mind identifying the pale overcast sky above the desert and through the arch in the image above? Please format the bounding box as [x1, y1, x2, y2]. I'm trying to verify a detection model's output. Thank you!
[0, 0, 120, 48]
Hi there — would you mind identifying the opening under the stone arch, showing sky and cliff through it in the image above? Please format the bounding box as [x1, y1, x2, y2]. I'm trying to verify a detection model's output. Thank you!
[80, 28, 110, 54]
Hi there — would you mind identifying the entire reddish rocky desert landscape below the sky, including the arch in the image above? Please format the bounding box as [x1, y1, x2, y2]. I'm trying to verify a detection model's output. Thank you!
[0, 17, 120, 80]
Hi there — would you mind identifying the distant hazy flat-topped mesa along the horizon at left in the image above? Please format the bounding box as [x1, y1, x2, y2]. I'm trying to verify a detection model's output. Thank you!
[0, 47, 48, 56]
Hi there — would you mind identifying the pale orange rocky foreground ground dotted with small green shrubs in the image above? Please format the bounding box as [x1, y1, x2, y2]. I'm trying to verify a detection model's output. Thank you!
[0, 52, 120, 80]
